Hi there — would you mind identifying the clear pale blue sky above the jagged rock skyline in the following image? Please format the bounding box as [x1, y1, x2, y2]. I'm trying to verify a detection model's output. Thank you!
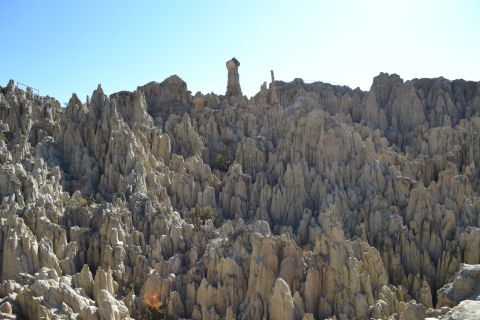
[0, 0, 480, 103]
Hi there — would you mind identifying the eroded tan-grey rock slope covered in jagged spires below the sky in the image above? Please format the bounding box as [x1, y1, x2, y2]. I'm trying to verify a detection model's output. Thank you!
[0, 60, 480, 320]
